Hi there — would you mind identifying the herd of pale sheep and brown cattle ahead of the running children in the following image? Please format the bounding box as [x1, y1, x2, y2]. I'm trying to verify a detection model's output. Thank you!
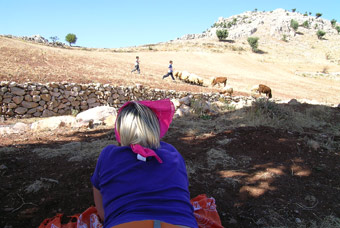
[174, 71, 272, 99]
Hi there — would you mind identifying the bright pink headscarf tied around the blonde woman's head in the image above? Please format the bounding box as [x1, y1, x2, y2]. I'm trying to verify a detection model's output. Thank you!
[115, 99, 175, 163]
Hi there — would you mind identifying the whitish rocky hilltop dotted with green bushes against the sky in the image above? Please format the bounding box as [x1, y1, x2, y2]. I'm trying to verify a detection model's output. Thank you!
[178, 9, 340, 40]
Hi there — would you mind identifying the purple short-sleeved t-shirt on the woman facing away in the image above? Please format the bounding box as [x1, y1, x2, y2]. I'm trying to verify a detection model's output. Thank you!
[91, 142, 198, 227]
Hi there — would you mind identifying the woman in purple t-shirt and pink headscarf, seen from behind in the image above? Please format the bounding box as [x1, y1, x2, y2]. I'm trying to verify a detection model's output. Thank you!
[91, 99, 198, 228]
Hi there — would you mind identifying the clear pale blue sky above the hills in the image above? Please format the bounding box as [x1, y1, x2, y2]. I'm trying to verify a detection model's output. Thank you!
[0, 0, 340, 48]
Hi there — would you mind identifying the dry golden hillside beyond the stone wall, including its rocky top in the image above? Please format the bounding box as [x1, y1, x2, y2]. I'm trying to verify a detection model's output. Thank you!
[0, 10, 340, 103]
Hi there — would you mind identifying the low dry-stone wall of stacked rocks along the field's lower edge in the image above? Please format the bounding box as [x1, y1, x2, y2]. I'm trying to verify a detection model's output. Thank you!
[0, 81, 231, 118]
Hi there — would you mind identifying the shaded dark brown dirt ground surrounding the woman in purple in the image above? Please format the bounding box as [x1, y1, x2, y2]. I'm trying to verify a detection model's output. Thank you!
[0, 105, 340, 228]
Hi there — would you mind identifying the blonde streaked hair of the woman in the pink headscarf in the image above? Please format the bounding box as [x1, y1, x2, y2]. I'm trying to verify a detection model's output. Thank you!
[116, 102, 160, 148]
